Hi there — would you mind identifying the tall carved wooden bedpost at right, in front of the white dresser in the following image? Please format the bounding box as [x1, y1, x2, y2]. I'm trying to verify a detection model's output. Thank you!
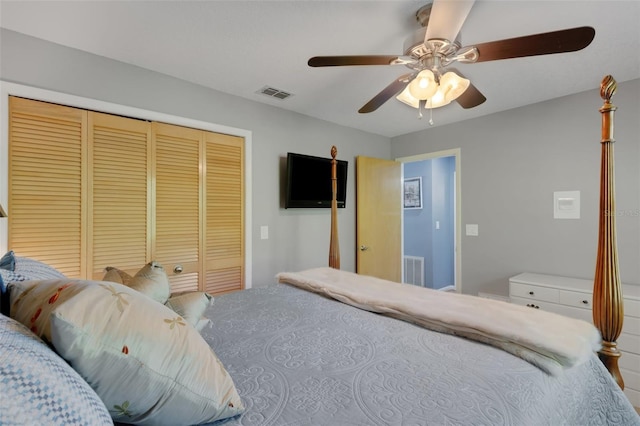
[593, 75, 624, 389]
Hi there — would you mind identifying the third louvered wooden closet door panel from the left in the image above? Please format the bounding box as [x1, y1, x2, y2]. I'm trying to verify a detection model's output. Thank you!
[152, 123, 202, 292]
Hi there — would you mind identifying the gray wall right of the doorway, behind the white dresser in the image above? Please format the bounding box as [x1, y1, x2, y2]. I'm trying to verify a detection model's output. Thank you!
[391, 80, 640, 294]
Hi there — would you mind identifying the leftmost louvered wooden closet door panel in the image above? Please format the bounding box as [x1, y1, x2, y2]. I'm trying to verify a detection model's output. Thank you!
[8, 97, 87, 277]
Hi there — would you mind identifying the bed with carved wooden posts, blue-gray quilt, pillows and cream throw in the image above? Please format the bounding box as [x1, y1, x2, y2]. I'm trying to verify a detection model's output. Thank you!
[0, 77, 640, 426]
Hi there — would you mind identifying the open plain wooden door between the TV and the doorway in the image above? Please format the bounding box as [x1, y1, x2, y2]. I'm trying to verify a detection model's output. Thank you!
[356, 157, 402, 282]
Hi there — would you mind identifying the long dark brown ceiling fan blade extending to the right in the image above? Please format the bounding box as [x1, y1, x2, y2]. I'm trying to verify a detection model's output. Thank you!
[475, 27, 596, 62]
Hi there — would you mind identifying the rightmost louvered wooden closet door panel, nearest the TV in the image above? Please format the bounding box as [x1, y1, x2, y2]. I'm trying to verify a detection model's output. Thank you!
[205, 132, 244, 293]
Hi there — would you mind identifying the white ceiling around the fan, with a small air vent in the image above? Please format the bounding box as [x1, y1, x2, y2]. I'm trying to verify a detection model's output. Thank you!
[0, 0, 640, 137]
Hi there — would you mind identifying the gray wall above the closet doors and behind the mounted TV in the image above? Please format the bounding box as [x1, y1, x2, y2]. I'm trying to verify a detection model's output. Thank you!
[0, 29, 390, 287]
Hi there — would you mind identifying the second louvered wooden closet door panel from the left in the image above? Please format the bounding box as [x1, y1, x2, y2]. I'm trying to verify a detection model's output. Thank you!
[89, 113, 152, 279]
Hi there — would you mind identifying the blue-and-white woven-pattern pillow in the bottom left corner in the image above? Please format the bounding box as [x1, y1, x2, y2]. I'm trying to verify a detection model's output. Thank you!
[0, 315, 113, 425]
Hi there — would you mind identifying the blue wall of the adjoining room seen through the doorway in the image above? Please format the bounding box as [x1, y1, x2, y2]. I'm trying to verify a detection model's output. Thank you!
[404, 157, 455, 288]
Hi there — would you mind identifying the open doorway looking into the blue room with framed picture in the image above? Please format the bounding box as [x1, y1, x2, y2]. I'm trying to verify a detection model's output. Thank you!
[396, 148, 461, 292]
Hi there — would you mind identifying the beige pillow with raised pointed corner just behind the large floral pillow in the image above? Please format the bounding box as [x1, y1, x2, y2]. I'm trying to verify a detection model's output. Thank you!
[102, 260, 171, 305]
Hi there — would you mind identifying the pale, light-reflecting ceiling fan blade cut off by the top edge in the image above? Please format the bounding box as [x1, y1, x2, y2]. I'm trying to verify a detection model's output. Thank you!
[424, 0, 475, 41]
